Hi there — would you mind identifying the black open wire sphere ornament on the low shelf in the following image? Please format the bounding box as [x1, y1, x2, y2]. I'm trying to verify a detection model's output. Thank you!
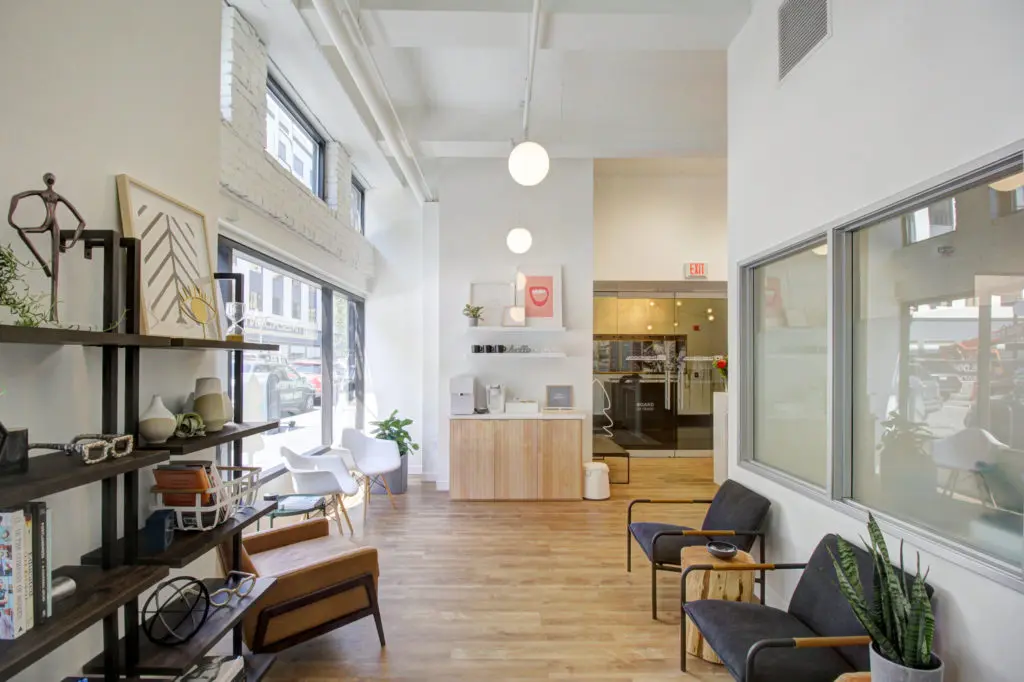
[142, 578, 210, 646]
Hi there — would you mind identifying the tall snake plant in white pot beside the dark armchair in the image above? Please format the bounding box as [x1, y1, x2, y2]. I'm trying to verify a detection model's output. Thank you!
[829, 514, 943, 682]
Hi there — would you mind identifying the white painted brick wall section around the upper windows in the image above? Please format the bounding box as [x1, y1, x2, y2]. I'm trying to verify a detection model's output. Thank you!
[220, 5, 375, 278]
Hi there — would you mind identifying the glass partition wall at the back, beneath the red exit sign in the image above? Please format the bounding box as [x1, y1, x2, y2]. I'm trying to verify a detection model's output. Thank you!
[593, 292, 728, 451]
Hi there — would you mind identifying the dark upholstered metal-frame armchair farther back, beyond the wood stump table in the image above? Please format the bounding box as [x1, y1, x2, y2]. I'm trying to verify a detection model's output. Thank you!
[626, 480, 771, 620]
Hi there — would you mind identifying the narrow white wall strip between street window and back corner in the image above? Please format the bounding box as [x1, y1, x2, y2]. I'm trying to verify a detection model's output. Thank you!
[366, 187, 426, 473]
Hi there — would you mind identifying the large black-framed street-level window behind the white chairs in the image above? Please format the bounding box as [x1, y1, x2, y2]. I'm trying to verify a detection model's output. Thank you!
[219, 239, 362, 469]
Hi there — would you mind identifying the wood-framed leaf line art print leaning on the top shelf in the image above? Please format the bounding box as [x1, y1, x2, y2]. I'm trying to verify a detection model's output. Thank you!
[117, 175, 220, 339]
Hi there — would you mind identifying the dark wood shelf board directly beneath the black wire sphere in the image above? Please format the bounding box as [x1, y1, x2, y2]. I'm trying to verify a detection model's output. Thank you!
[82, 578, 276, 676]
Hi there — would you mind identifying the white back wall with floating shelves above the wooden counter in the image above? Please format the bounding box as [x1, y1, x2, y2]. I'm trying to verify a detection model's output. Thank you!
[433, 159, 594, 489]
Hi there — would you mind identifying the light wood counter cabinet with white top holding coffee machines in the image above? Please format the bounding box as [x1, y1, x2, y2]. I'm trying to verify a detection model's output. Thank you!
[451, 412, 587, 500]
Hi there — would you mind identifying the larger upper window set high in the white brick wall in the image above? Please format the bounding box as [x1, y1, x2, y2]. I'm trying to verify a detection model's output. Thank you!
[266, 80, 324, 198]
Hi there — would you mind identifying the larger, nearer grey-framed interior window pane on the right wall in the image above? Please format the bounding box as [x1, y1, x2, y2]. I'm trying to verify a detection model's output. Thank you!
[851, 166, 1024, 562]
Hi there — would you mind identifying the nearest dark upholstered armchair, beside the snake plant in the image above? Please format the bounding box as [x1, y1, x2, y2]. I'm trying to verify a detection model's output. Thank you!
[679, 535, 932, 682]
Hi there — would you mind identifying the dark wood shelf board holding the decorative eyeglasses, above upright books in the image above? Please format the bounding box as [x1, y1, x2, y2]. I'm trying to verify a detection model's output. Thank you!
[0, 450, 170, 507]
